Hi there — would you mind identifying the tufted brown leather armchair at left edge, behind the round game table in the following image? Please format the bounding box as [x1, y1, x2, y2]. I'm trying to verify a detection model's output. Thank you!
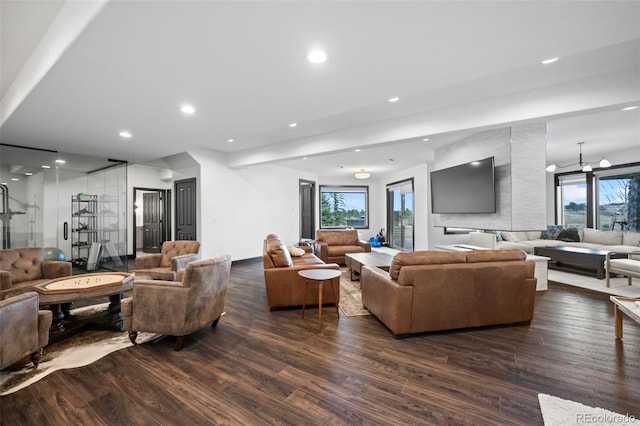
[0, 247, 72, 300]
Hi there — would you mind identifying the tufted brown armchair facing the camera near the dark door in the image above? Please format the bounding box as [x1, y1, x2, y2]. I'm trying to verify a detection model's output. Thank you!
[131, 240, 200, 281]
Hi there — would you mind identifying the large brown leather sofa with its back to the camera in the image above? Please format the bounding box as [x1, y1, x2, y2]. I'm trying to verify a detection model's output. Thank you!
[361, 250, 536, 337]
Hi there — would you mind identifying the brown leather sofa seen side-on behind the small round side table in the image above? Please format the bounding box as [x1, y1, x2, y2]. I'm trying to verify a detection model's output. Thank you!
[262, 234, 340, 311]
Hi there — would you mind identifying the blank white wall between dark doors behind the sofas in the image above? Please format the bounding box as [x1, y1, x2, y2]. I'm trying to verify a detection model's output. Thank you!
[189, 149, 318, 260]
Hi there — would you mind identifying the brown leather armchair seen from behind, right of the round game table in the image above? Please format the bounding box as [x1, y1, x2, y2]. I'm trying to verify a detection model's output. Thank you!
[121, 255, 231, 351]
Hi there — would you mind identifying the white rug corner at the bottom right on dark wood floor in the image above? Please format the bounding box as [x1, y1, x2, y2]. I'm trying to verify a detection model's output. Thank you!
[538, 393, 638, 426]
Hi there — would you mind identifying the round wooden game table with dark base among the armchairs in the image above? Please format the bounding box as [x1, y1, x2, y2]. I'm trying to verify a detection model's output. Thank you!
[34, 272, 134, 342]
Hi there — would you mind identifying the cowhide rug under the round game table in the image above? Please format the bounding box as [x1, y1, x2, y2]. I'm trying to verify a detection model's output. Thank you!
[0, 303, 162, 395]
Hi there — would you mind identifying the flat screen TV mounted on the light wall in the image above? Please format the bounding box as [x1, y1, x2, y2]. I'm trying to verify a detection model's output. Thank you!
[431, 157, 496, 213]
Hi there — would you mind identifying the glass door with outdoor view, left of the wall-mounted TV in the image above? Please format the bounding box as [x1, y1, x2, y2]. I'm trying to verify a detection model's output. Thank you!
[387, 179, 414, 251]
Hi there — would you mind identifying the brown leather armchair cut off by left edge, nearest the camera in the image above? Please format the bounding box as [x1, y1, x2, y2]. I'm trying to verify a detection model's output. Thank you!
[0, 291, 53, 370]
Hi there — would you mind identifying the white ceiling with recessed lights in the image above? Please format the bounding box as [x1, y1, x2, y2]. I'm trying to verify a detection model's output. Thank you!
[0, 0, 640, 176]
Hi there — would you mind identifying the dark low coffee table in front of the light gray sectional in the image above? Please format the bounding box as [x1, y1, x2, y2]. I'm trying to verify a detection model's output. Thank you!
[534, 246, 627, 280]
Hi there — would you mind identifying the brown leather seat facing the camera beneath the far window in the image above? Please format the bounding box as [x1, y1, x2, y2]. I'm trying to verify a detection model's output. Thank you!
[315, 229, 371, 265]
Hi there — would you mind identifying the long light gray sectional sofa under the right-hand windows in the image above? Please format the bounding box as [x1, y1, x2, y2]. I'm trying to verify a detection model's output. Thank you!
[469, 228, 640, 254]
